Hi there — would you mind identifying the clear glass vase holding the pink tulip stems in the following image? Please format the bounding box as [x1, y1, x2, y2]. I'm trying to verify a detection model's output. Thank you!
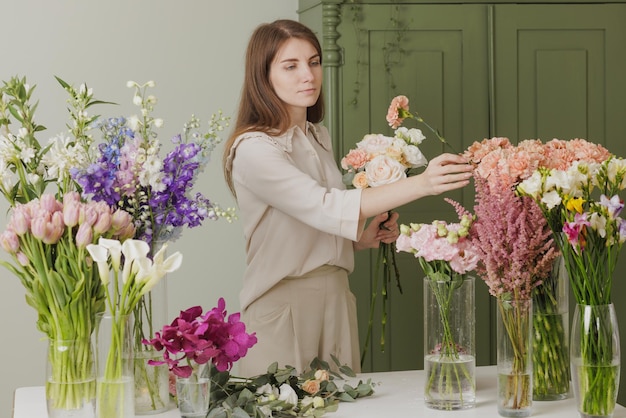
[46, 337, 96, 418]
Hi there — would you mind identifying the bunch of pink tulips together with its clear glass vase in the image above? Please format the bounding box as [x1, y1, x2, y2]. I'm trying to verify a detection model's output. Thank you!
[0, 192, 134, 416]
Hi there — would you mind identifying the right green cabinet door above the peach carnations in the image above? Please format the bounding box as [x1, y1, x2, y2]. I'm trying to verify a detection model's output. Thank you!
[494, 4, 626, 146]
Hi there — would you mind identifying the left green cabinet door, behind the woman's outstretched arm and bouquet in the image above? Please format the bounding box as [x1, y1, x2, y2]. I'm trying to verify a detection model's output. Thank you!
[337, 4, 491, 371]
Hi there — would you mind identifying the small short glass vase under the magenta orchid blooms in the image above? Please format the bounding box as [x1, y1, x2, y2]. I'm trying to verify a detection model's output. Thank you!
[176, 361, 212, 418]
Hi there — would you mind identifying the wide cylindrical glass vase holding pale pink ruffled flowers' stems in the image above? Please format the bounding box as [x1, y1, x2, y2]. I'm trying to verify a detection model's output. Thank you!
[424, 274, 476, 410]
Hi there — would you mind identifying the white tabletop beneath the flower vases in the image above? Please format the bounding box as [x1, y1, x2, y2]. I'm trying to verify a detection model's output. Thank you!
[13, 366, 626, 418]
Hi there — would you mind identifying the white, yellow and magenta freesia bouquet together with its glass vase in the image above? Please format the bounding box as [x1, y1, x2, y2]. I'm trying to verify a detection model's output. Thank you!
[518, 148, 626, 416]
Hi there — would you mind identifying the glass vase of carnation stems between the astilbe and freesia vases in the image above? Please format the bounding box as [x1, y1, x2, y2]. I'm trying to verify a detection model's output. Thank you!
[532, 256, 570, 401]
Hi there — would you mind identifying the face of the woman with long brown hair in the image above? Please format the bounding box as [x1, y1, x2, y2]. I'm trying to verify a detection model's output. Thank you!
[270, 38, 322, 123]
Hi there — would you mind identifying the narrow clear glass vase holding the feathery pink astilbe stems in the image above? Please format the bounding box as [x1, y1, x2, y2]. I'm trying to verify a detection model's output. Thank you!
[496, 297, 533, 417]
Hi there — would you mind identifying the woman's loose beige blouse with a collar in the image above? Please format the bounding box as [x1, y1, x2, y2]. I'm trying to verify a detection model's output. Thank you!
[227, 123, 362, 310]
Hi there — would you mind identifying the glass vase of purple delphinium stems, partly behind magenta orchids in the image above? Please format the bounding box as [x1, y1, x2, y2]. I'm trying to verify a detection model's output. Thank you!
[133, 278, 170, 415]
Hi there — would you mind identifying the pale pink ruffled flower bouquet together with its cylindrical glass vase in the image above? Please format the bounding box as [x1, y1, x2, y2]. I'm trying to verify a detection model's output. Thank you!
[396, 199, 478, 409]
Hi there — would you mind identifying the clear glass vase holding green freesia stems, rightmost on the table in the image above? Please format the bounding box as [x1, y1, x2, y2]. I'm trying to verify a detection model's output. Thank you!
[570, 304, 621, 418]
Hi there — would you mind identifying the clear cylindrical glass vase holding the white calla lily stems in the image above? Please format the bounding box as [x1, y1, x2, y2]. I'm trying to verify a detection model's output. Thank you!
[96, 313, 135, 418]
